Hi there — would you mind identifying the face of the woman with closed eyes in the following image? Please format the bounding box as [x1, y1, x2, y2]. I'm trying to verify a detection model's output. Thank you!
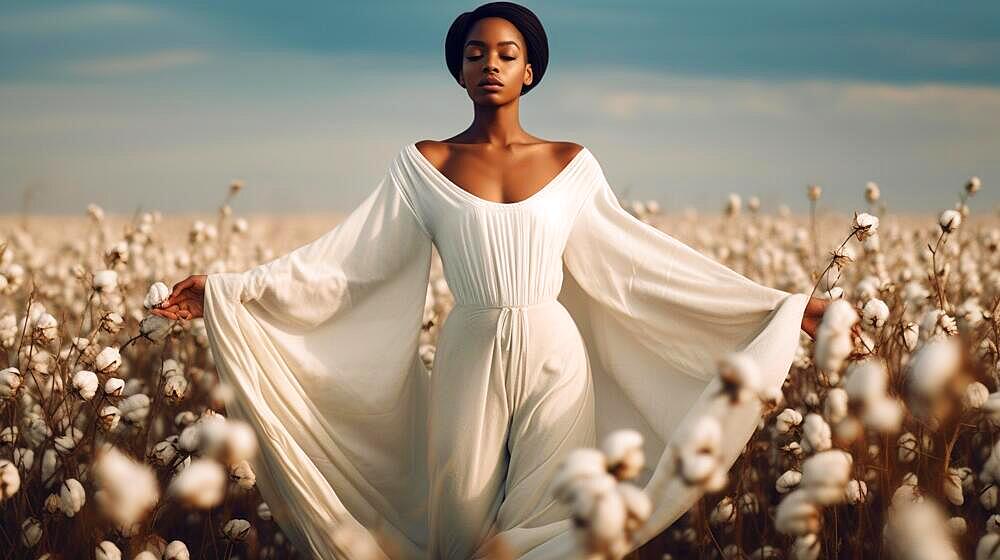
[459, 17, 532, 105]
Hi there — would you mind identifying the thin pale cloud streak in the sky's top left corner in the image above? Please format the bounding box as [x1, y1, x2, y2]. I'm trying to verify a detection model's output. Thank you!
[0, 3, 163, 35]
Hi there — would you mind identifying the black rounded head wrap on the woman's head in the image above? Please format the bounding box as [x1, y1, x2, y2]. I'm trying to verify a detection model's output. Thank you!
[444, 2, 549, 95]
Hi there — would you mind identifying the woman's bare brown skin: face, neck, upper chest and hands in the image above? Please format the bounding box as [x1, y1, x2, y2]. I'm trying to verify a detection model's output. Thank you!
[152, 17, 840, 344]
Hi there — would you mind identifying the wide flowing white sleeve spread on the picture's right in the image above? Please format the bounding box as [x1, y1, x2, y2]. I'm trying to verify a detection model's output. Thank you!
[559, 160, 809, 544]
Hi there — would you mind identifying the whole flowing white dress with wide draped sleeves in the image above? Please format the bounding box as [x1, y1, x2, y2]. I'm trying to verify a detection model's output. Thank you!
[204, 143, 809, 560]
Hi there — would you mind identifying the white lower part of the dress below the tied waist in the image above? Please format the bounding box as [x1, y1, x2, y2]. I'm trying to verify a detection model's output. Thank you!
[428, 299, 596, 560]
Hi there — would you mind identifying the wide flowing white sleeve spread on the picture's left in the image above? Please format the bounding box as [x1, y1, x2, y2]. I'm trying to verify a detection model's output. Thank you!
[204, 159, 432, 558]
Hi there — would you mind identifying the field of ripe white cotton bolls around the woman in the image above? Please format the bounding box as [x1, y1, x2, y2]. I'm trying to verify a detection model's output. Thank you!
[0, 177, 1000, 560]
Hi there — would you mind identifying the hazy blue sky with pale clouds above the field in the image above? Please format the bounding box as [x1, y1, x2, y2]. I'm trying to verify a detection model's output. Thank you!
[0, 0, 1000, 213]
